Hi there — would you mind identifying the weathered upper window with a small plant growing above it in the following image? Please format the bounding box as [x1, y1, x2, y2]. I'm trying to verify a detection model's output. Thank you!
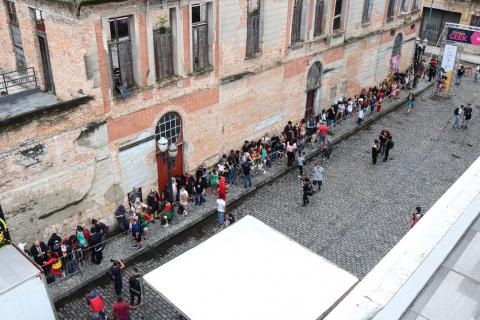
[153, 28, 174, 80]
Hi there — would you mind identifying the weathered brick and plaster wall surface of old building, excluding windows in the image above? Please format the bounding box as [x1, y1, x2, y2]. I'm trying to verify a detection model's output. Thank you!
[0, 0, 418, 240]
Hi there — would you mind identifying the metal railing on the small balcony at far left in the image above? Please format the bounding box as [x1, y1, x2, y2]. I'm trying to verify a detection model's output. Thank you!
[0, 67, 37, 95]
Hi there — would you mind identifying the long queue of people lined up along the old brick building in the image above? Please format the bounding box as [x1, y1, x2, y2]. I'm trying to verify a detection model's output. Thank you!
[26, 67, 424, 292]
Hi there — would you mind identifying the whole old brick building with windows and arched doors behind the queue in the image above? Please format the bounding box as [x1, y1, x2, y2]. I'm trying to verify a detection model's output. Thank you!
[0, 0, 422, 241]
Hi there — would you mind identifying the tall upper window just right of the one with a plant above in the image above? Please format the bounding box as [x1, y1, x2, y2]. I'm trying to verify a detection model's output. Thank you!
[192, 5, 210, 71]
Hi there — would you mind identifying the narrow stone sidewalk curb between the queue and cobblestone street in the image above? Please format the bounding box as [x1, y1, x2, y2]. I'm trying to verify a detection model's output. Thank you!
[52, 82, 433, 303]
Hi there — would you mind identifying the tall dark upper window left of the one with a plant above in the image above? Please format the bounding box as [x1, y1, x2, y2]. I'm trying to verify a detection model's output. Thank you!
[108, 17, 135, 93]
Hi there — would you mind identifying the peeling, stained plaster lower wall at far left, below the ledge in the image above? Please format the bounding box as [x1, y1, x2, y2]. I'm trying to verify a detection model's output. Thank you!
[0, 123, 118, 242]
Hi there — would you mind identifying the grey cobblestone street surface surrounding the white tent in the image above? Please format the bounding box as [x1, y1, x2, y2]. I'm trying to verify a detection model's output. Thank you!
[57, 80, 480, 319]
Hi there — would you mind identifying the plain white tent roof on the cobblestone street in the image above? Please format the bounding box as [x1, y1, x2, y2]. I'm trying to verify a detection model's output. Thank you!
[144, 216, 358, 320]
